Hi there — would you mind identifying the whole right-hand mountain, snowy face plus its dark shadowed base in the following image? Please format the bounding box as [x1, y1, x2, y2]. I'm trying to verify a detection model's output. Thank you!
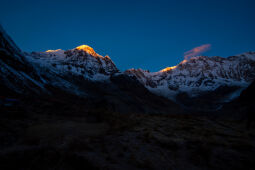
[125, 52, 255, 109]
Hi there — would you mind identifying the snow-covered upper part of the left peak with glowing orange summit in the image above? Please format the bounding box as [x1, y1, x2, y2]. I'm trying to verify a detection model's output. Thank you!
[26, 45, 119, 81]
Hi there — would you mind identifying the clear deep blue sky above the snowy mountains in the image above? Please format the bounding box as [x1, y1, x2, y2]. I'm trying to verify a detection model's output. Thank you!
[0, 0, 255, 71]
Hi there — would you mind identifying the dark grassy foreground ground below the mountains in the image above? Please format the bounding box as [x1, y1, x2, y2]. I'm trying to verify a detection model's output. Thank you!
[0, 96, 255, 170]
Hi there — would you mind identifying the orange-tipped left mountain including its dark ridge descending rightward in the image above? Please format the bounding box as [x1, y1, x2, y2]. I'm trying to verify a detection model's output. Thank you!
[26, 45, 180, 113]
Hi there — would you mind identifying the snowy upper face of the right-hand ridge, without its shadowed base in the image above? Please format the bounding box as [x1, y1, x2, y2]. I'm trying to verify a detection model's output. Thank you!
[125, 52, 255, 99]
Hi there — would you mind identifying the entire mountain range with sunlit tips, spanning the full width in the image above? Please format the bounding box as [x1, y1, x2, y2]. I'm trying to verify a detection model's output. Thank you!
[0, 27, 255, 113]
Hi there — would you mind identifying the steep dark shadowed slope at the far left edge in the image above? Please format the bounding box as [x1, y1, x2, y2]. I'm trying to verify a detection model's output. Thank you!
[0, 26, 45, 95]
